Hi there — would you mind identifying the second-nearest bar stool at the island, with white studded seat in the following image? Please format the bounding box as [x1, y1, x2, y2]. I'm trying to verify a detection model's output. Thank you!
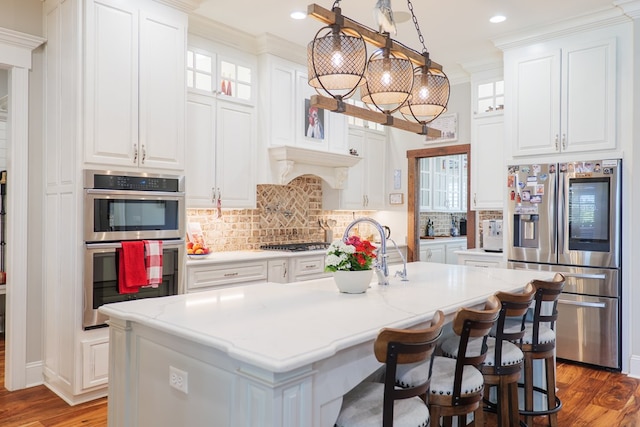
[429, 295, 500, 427]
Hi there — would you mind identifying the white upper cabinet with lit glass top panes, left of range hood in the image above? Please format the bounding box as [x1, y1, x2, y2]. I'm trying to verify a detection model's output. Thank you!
[185, 44, 257, 208]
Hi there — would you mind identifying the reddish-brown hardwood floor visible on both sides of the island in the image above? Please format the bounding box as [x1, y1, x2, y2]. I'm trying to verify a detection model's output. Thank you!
[0, 336, 640, 427]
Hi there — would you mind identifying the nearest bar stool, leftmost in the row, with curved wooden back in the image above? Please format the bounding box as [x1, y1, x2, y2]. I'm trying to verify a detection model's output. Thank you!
[335, 311, 444, 427]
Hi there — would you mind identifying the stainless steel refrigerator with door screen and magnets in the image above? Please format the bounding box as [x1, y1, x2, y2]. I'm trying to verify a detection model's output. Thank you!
[504, 159, 622, 370]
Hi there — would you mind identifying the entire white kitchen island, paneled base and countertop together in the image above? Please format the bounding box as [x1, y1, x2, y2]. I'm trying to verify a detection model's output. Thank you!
[100, 262, 549, 427]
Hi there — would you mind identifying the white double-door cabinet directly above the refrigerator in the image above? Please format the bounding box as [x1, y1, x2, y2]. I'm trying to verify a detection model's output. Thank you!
[504, 34, 616, 156]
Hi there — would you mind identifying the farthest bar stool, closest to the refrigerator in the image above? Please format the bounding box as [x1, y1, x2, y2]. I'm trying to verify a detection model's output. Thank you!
[520, 273, 565, 427]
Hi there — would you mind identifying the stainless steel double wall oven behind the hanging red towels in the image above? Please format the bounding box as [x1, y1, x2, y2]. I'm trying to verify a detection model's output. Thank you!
[82, 170, 185, 329]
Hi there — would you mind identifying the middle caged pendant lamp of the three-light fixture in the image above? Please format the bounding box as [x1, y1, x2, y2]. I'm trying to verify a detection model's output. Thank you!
[360, 33, 413, 114]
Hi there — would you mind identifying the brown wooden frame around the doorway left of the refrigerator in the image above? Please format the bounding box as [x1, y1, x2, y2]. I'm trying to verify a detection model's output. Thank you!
[407, 144, 476, 261]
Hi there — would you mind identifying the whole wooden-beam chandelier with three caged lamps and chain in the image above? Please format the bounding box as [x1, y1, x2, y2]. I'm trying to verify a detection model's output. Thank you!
[307, 0, 449, 137]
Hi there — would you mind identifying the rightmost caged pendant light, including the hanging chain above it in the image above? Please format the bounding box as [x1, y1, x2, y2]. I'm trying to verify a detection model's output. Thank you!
[399, 0, 450, 124]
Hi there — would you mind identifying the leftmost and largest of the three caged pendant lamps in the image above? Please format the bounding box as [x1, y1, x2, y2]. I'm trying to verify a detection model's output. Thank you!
[307, 0, 367, 101]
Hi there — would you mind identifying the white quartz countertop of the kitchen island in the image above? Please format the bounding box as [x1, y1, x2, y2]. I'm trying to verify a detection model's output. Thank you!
[100, 262, 549, 372]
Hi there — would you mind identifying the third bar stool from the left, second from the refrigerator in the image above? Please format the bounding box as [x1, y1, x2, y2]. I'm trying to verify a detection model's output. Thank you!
[482, 283, 535, 427]
